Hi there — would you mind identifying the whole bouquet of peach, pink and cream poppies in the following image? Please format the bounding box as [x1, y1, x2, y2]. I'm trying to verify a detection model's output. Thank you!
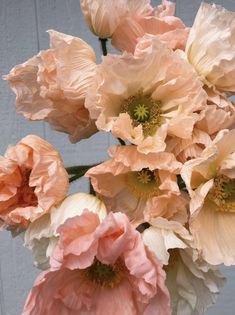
[0, 0, 235, 315]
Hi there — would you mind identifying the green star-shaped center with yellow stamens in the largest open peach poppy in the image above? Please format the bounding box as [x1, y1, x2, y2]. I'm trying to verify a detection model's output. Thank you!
[121, 92, 162, 136]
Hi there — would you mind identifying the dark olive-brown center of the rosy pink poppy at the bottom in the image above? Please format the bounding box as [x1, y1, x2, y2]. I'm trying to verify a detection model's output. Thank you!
[85, 258, 125, 288]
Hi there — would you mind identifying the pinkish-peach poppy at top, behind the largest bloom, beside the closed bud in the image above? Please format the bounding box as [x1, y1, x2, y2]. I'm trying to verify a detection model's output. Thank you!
[112, 1, 189, 53]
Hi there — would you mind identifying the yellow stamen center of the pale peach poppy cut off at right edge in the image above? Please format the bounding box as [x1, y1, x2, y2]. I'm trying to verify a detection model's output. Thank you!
[208, 175, 235, 212]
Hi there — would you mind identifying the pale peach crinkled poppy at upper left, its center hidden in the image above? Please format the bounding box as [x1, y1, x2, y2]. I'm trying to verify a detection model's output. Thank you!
[4, 30, 97, 142]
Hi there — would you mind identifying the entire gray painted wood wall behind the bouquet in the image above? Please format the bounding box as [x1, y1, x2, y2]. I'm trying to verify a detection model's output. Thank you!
[0, 0, 235, 315]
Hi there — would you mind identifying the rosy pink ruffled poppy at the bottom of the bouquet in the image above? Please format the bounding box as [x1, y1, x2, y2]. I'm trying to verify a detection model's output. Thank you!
[22, 210, 171, 315]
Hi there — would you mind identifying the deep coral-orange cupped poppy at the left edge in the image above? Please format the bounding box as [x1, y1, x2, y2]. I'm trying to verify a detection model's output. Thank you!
[0, 135, 69, 228]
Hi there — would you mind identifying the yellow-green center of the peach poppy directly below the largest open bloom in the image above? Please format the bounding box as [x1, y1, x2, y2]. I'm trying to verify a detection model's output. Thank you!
[126, 168, 160, 199]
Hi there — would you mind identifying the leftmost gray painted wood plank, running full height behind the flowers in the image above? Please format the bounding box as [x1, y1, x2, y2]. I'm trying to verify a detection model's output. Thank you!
[0, 0, 43, 315]
